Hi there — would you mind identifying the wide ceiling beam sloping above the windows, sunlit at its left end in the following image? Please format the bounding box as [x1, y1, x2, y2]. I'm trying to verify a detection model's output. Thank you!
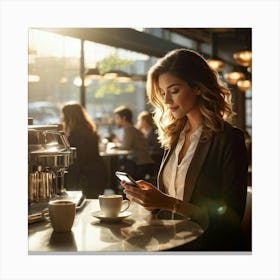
[37, 28, 186, 57]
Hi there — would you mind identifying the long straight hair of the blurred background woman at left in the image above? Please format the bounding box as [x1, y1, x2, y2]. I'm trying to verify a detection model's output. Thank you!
[62, 102, 97, 136]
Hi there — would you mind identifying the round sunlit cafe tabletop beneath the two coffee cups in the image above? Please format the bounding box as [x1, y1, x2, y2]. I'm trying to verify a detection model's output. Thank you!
[28, 199, 203, 254]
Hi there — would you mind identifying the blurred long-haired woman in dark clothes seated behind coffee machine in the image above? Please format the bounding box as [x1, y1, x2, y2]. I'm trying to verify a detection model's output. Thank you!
[61, 103, 107, 198]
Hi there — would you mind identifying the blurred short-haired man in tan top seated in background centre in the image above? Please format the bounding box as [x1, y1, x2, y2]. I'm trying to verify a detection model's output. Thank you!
[114, 106, 153, 180]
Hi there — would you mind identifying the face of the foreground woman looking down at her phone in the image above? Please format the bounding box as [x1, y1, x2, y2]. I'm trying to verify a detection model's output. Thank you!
[158, 72, 198, 119]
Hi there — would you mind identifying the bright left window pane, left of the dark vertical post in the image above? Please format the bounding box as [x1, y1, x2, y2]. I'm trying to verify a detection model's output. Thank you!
[28, 29, 80, 124]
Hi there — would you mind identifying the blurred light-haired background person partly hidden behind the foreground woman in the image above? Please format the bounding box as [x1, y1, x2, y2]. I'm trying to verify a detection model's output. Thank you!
[136, 111, 163, 175]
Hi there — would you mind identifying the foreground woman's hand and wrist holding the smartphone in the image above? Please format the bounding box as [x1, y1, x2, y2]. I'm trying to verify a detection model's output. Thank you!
[121, 180, 173, 211]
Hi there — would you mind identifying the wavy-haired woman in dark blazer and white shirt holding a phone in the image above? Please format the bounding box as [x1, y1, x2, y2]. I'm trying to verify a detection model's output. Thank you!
[122, 49, 247, 250]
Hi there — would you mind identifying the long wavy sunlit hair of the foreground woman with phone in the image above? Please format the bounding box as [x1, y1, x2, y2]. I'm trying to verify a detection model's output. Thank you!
[147, 49, 233, 149]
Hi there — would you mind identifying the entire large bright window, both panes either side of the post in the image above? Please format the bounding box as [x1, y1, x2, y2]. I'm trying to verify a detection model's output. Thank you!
[28, 29, 156, 139]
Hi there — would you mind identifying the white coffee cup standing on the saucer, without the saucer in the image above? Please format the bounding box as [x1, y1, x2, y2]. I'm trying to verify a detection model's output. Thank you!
[98, 194, 130, 217]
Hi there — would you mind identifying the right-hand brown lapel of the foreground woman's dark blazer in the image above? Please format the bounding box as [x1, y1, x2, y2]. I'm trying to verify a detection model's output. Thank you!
[184, 138, 211, 201]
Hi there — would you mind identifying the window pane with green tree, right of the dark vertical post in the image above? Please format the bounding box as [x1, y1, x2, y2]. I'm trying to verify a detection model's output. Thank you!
[84, 41, 158, 136]
